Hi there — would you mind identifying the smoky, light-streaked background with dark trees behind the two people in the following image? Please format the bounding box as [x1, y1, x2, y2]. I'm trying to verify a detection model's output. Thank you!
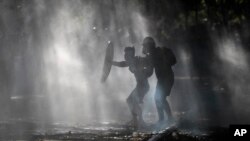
[0, 0, 250, 133]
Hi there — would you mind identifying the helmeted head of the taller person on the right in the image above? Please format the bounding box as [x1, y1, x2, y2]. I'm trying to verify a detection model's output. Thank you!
[142, 37, 156, 55]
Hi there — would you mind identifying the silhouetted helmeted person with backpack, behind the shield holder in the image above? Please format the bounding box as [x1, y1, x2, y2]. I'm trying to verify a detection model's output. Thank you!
[143, 37, 176, 124]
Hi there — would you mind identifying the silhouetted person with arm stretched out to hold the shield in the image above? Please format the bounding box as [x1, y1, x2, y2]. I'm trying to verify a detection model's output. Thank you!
[112, 47, 153, 126]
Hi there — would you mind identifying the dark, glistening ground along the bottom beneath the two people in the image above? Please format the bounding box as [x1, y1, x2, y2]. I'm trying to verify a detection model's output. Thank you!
[0, 120, 228, 141]
